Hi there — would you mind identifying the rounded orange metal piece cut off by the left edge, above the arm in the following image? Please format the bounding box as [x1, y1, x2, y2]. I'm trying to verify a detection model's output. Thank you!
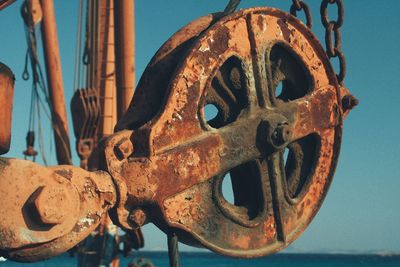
[0, 62, 14, 155]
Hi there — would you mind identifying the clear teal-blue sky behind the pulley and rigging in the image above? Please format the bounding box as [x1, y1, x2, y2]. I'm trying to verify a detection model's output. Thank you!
[0, 0, 400, 255]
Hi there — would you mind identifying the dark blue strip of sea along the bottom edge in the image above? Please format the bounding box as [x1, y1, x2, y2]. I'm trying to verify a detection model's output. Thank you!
[0, 252, 400, 267]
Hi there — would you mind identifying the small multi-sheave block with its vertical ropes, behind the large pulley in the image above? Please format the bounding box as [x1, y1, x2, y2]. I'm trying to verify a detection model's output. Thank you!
[71, 0, 100, 169]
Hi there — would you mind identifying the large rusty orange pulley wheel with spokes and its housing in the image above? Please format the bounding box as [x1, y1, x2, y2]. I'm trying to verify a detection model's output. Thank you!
[105, 8, 345, 257]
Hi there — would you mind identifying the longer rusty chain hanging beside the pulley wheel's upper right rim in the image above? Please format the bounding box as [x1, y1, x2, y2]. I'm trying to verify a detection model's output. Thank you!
[321, 0, 346, 85]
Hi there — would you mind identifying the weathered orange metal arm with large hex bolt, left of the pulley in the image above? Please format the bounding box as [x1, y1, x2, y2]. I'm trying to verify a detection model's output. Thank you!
[0, 158, 116, 261]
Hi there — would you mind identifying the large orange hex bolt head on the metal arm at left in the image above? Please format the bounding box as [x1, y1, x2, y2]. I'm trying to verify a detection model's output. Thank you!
[35, 186, 74, 224]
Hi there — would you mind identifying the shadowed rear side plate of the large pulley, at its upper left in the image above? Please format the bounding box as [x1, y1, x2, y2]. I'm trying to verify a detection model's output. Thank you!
[115, 14, 220, 131]
